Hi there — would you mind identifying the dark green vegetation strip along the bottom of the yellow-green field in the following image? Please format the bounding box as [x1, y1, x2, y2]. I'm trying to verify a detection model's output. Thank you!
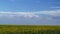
[0, 30, 60, 34]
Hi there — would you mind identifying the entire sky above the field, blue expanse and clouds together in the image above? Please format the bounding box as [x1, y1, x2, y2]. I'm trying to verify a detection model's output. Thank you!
[0, 0, 60, 25]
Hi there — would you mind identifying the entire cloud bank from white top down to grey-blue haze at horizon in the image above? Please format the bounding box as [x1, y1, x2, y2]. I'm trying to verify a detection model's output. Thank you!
[0, 10, 60, 25]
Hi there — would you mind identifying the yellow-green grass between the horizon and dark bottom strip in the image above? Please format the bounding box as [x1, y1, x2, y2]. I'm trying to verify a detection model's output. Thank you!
[0, 25, 60, 34]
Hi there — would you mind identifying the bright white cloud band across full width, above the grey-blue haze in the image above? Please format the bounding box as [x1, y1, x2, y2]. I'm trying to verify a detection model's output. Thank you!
[0, 10, 60, 18]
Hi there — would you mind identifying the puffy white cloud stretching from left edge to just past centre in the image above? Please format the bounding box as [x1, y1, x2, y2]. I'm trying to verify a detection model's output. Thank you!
[0, 12, 39, 18]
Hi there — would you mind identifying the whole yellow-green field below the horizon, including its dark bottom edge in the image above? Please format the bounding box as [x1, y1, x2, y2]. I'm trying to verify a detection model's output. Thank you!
[0, 25, 60, 34]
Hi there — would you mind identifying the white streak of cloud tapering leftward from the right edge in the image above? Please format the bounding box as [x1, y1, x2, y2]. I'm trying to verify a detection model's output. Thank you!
[34, 10, 60, 16]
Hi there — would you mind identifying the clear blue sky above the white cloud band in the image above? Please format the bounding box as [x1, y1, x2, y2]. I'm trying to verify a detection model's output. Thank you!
[0, 0, 60, 11]
